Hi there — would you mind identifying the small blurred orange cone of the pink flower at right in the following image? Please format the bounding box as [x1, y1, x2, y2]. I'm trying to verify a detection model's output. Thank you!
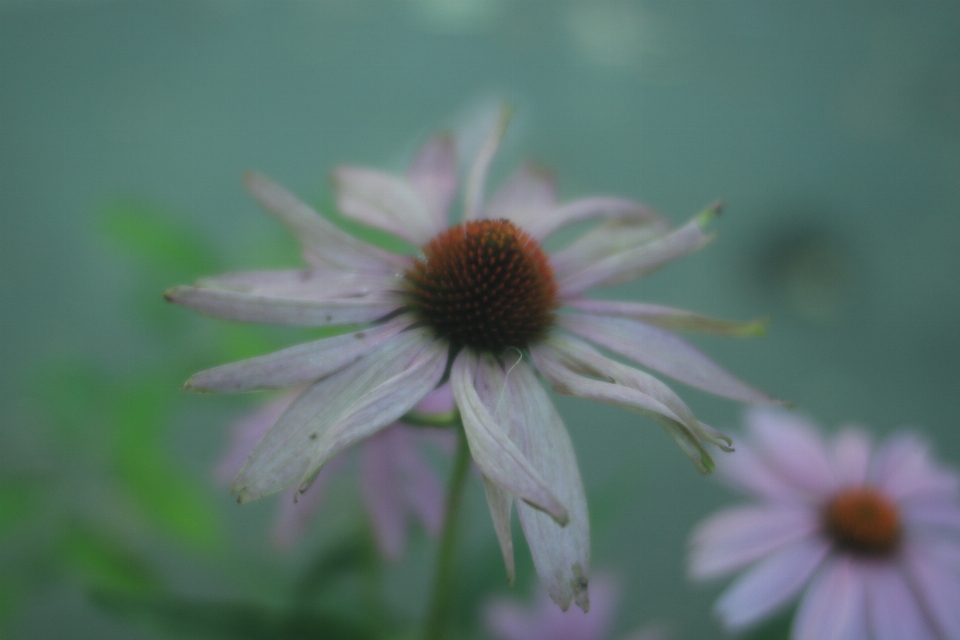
[824, 487, 900, 556]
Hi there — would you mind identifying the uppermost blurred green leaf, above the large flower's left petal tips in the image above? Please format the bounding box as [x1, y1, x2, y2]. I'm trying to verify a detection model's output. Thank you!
[99, 200, 216, 278]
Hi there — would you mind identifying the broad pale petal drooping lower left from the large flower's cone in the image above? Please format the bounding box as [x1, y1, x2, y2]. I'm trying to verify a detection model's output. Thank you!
[233, 329, 446, 502]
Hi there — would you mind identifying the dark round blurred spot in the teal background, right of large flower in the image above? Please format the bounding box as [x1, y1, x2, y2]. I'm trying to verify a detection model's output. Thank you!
[751, 215, 858, 322]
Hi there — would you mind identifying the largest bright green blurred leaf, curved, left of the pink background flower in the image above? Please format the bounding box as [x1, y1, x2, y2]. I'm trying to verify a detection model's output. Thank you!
[114, 380, 221, 547]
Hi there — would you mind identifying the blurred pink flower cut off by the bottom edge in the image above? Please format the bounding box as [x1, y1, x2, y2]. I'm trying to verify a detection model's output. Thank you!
[484, 576, 665, 640]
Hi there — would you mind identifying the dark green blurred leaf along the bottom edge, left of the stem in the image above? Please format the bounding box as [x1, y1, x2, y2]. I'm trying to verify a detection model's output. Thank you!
[94, 591, 377, 640]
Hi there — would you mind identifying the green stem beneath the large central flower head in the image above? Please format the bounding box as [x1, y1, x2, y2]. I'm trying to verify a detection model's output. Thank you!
[424, 424, 470, 640]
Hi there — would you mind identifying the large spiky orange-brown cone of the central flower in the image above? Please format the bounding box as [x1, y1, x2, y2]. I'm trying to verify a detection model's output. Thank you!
[406, 220, 557, 353]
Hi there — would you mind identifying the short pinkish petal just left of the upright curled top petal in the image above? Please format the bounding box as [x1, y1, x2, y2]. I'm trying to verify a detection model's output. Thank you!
[407, 134, 457, 233]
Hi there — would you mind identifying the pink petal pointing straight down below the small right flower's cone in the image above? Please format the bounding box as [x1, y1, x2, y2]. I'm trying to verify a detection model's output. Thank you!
[791, 556, 868, 640]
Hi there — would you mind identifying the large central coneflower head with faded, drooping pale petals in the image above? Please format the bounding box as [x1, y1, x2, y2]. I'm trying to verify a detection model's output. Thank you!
[167, 109, 771, 610]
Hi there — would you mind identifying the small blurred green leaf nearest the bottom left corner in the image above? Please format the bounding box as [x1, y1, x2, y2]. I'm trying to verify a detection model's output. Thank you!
[59, 525, 160, 593]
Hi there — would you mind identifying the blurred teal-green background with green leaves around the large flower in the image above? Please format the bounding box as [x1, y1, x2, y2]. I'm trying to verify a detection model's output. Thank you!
[0, 0, 960, 639]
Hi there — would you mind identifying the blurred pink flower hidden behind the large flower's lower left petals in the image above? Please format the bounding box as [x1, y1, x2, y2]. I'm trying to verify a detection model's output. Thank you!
[216, 385, 455, 560]
